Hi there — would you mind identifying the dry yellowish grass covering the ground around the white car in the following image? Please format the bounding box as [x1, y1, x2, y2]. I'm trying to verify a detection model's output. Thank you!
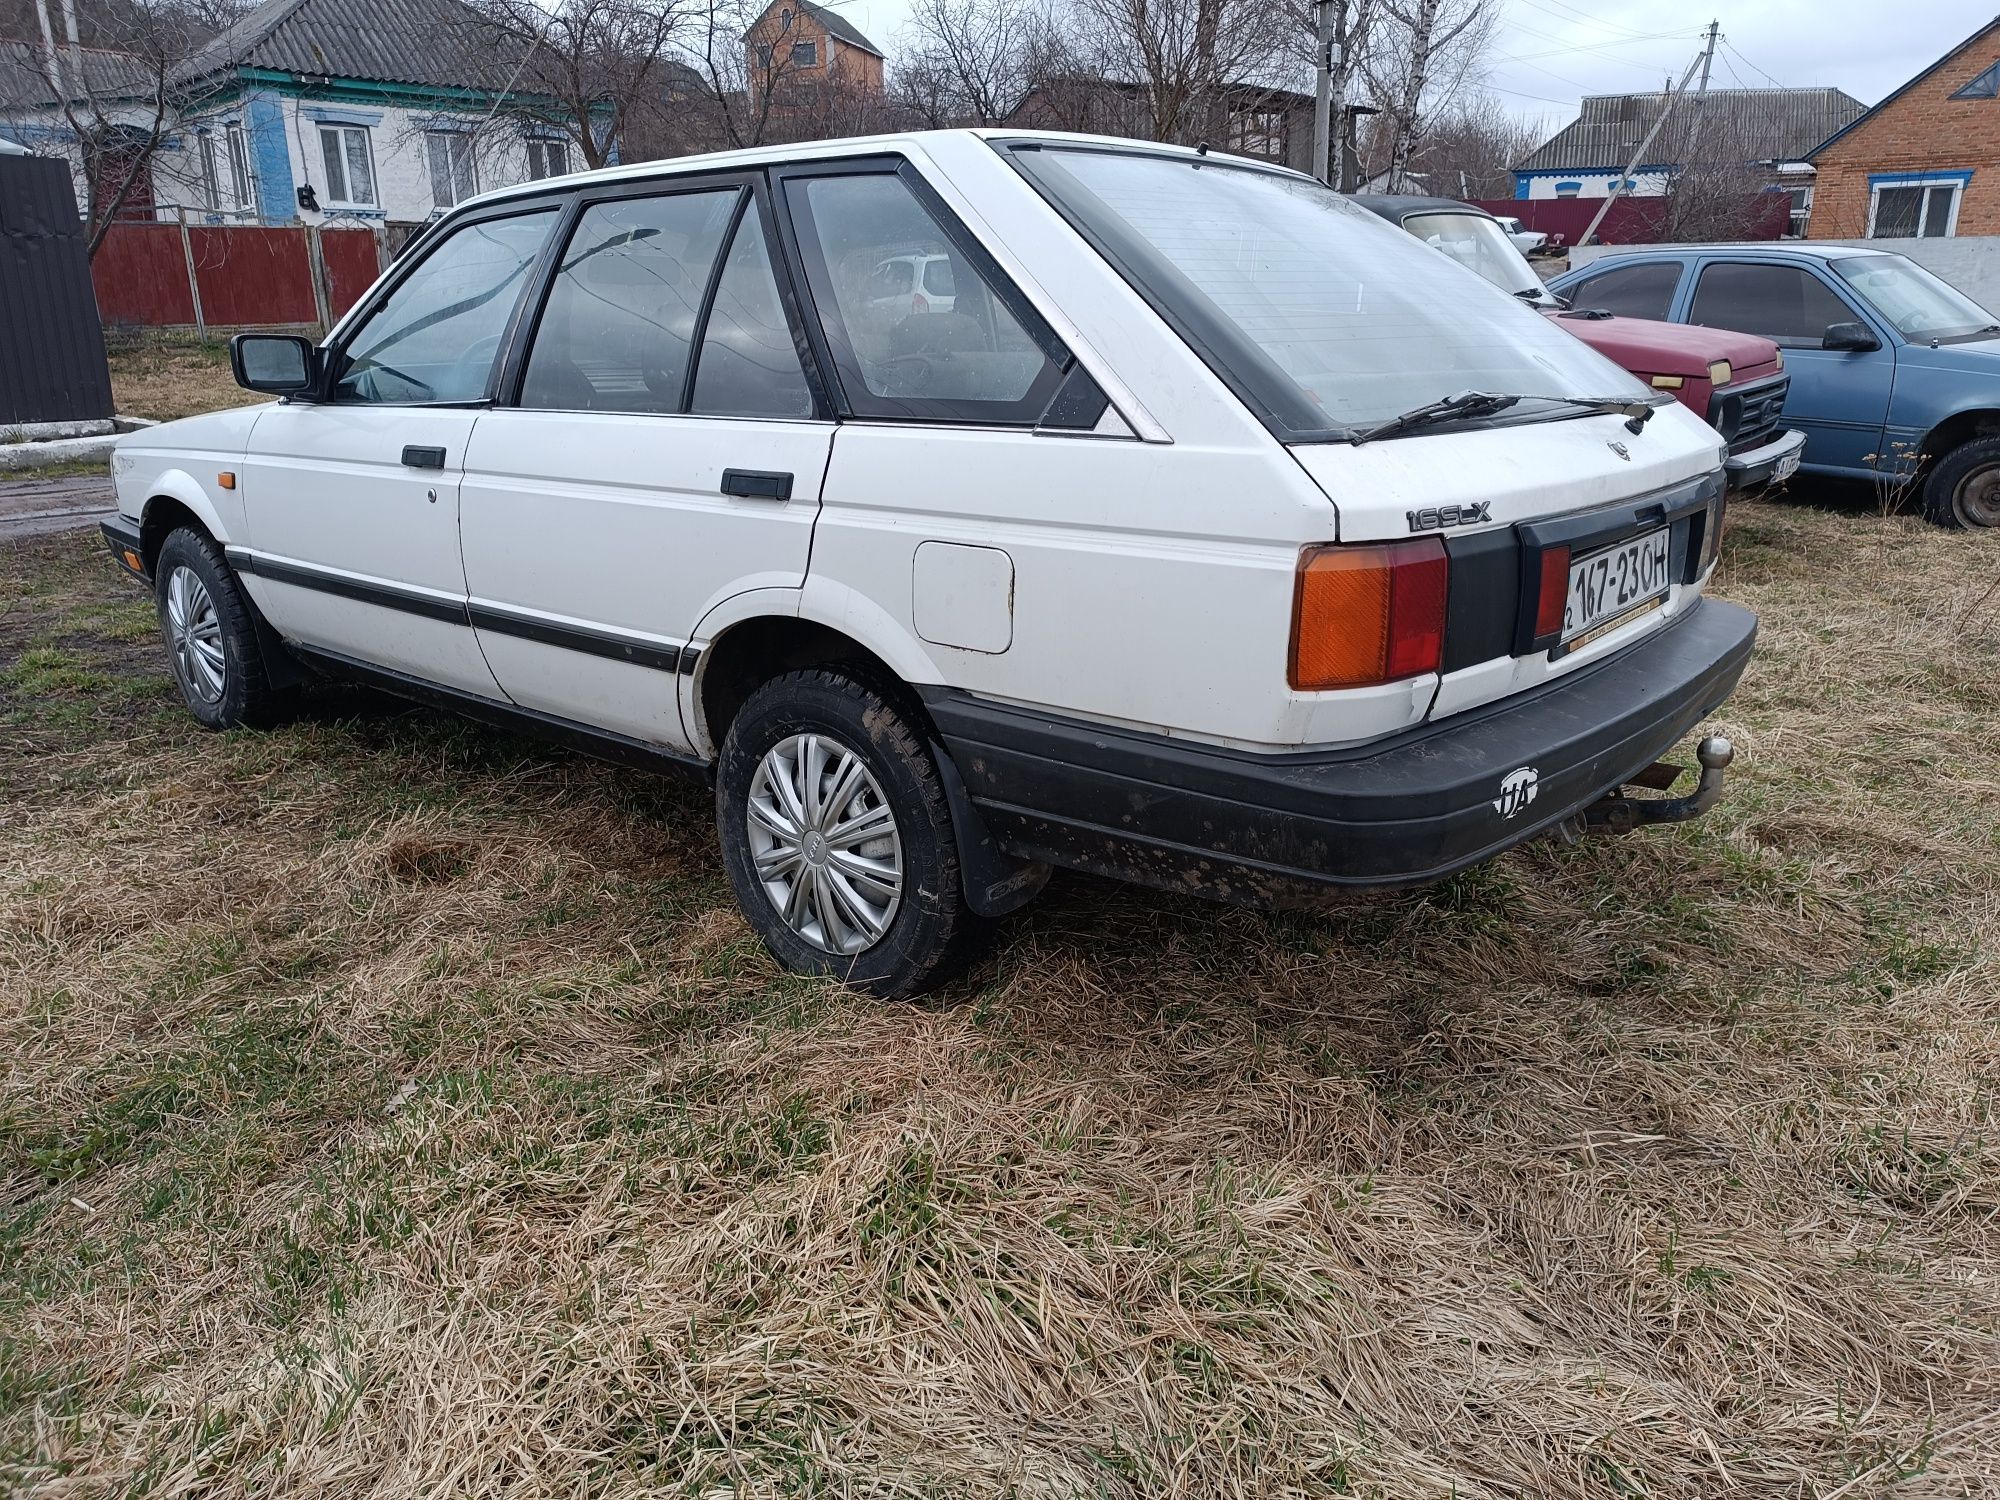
[0, 496, 2000, 1500]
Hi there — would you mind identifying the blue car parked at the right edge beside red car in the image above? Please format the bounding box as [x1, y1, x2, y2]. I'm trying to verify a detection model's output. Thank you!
[1550, 244, 2000, 526]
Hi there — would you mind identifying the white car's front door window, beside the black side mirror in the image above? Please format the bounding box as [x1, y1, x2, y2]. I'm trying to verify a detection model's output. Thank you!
[332, 208, 558, 406]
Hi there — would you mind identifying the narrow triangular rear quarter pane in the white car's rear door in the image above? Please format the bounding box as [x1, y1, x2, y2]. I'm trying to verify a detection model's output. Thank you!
[692, 204, 812, 416]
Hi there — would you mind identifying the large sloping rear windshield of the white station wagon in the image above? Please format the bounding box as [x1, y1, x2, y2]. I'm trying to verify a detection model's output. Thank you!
[1014, 144, 1644, 442]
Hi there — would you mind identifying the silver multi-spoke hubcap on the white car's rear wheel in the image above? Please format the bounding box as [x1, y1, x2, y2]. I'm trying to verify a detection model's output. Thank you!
[748, 734, 902, 954]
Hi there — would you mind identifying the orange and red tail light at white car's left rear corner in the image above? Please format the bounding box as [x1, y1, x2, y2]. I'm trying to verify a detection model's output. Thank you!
[1290, 536, 1448, 692]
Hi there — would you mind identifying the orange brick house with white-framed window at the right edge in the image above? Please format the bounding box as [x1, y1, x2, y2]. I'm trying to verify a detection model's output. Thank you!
[1806, 20, 2000, 240]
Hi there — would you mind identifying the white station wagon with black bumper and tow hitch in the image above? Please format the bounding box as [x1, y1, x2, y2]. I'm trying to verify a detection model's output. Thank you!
[104, 132, 1756, 994]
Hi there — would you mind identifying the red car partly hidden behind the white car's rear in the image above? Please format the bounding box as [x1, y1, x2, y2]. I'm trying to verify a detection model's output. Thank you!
[1354, 194, 1806, 496]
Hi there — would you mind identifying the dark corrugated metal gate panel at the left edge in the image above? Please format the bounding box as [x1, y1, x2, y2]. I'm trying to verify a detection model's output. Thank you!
[0, 156, 112, 428]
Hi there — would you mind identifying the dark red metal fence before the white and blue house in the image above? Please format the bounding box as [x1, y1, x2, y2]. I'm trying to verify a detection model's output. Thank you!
[90, 212, 388, 338]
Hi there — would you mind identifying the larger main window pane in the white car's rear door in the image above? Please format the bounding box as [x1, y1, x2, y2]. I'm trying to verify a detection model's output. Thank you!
[520, 186, 742, 414]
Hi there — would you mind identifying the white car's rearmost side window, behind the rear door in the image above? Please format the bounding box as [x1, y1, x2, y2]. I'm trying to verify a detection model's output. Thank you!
[786, 172, 1066, 424]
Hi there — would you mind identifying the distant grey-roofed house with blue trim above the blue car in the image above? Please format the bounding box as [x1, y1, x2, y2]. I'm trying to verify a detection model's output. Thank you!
[1514, 88, 1866, 226]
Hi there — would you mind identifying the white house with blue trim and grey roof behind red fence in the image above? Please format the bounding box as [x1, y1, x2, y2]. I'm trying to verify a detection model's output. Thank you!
[0, 0, 582, 224]
